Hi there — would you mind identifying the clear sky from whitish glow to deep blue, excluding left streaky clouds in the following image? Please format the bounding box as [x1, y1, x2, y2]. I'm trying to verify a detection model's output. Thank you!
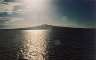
[0, 0, 96, 28]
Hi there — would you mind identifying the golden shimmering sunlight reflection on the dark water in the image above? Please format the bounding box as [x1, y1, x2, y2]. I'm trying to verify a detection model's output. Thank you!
[21, 30, 48, 60]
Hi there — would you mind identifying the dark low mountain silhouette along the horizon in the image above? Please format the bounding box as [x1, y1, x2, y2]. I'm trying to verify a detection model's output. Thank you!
[1, 24, 96, 30]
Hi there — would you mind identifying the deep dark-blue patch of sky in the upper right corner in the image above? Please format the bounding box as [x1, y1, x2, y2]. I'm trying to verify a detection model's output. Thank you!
[53, 0, 96, 23]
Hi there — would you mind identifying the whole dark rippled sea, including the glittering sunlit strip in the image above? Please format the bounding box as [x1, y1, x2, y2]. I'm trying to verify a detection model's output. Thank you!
[0, 28, 96, 60]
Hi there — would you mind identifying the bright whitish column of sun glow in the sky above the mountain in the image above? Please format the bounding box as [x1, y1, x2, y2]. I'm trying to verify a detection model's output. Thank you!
[22, 0, 52, 25]
